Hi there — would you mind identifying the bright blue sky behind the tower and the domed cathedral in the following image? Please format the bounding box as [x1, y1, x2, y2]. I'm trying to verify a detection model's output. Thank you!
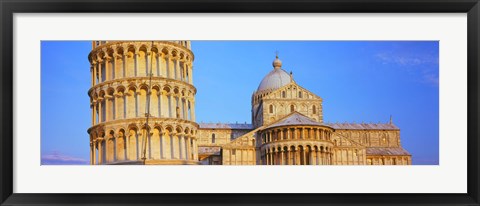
[41, 41, 439, 165]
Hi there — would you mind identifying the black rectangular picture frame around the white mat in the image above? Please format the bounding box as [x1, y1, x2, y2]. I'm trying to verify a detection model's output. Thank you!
[0, 0, 480, 205]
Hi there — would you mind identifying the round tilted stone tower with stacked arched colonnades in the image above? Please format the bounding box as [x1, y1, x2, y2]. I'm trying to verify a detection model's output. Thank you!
[88, 41, 198, 165]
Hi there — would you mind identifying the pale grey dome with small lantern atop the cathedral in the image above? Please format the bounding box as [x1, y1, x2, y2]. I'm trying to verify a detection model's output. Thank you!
[257, 56, 291, 92]
